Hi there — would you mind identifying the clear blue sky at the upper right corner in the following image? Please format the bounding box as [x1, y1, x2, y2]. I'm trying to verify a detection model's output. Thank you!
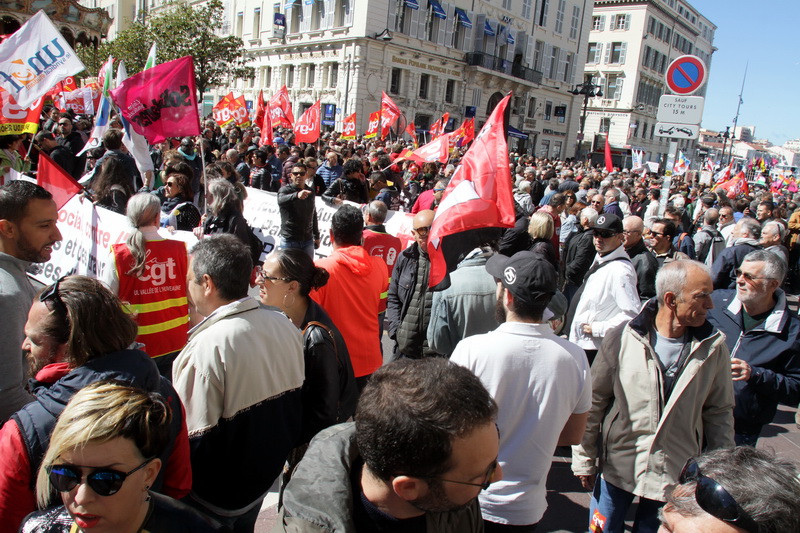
[689, 0, 800, 145]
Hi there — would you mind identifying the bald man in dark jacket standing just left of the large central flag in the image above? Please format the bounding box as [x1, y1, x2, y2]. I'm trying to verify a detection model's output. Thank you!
[386, 209, 436, 359]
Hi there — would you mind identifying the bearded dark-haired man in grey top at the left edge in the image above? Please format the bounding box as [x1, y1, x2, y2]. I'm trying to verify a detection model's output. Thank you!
[0, 180, 61, 425]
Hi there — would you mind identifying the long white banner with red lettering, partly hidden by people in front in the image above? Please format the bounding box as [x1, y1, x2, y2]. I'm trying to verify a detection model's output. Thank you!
[31, 187, 414, 285]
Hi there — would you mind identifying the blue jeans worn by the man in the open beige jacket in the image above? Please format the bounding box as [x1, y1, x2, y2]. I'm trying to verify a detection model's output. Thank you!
[589, 475, 664, 533]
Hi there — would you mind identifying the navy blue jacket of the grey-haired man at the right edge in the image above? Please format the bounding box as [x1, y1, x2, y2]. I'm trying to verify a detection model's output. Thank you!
[708, 289, 800, 434]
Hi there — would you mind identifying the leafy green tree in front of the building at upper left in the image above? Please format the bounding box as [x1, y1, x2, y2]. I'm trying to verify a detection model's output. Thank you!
[148, 0, 255, 98]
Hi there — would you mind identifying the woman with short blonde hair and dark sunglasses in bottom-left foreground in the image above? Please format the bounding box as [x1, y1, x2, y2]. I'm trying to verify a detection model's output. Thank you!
[20, 381, 219, 533]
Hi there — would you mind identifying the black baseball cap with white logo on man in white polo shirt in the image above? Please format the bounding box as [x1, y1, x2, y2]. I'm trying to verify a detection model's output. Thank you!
[486, 250, 558, 303]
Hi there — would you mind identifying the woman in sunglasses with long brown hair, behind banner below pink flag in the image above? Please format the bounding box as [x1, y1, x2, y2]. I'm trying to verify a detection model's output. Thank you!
[156, 161, 201, 231]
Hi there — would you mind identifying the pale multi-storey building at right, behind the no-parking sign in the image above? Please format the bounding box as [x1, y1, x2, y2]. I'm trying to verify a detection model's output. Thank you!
[583, 0, 716, 166]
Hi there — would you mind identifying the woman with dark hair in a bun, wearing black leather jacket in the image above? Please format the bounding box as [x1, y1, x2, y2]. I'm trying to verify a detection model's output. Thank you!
[256, 248, 358, 448]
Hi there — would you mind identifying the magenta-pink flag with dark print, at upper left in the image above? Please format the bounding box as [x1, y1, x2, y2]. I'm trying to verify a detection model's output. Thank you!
[111, 56, 200, 144]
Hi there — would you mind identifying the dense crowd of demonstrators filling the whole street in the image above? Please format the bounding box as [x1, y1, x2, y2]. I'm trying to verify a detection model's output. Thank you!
[0, 105, 800, 533]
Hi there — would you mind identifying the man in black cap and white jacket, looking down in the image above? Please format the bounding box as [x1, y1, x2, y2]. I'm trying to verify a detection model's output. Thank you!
[569, 213, 641, 362]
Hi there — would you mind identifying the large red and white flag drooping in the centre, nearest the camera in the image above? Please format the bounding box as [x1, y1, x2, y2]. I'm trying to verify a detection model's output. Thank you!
[428, 93, 514, 287]
